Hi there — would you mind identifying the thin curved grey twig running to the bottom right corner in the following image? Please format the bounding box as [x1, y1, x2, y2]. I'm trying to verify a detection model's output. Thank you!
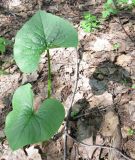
[67, 134, 133, 160]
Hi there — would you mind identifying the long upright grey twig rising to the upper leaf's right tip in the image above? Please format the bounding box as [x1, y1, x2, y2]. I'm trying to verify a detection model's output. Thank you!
[64, 49, 81, 160]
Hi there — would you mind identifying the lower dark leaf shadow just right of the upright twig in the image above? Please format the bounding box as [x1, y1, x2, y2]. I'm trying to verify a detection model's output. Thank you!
[70, 99, 103, 143]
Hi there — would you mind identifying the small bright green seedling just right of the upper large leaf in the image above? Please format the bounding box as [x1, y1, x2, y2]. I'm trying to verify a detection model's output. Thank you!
[80, 12, 100, 32]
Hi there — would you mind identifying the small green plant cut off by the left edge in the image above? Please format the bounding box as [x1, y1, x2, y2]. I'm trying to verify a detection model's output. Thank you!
[0, 37, 11, 54]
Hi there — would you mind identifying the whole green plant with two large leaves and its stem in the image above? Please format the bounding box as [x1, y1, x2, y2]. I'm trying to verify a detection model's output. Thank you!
[5, 10, 78, 150]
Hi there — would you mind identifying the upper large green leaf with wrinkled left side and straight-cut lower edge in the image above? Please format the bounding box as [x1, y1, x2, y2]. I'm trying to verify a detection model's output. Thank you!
[14, 11, 78, 73]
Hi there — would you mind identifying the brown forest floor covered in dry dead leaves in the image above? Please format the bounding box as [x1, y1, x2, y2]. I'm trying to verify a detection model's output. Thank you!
[0, 0, 135, 160]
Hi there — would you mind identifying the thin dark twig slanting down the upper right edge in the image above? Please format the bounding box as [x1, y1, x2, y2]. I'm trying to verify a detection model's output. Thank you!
[112, 0, 135, 46]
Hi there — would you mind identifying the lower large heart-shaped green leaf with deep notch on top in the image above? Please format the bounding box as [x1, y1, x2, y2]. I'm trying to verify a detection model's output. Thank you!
[5, 84, 65, 150]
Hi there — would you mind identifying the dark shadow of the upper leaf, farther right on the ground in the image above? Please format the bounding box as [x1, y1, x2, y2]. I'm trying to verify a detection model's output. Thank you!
[89, 61, 132, 95]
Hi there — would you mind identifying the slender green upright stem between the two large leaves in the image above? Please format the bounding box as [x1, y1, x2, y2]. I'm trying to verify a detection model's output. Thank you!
[47, 49, 52, 98]
